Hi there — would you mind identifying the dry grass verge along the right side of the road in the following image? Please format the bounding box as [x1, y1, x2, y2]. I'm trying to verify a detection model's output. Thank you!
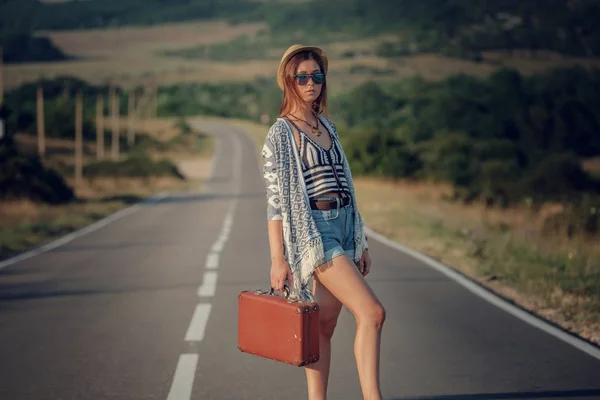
[231, 115, 600, 344]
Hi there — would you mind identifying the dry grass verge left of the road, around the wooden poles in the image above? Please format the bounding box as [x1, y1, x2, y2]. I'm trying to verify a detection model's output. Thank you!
[0, 119, 214, 258]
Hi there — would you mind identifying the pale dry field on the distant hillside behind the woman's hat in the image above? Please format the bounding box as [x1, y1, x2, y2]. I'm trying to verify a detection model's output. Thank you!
[5, 21, 600, 90]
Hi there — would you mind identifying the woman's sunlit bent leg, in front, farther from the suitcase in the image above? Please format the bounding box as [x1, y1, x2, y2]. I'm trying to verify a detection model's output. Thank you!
[315, 255, 385, 400]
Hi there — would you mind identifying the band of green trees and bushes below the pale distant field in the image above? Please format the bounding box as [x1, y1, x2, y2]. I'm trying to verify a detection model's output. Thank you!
[5, 63, 600, 234]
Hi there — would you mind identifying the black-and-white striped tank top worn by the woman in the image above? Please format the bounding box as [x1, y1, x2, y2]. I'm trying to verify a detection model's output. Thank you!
[290, 121, 350, 198]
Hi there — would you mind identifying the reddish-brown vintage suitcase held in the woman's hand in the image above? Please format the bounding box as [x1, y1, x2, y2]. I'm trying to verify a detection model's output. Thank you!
[238, 289, 319, 367]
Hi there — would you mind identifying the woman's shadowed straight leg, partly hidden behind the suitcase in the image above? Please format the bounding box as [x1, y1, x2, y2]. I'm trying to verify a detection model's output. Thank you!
[304, 279, 342, 400]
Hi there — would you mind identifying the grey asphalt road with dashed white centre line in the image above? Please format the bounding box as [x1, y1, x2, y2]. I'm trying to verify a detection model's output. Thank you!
[0, 123, 600, 400]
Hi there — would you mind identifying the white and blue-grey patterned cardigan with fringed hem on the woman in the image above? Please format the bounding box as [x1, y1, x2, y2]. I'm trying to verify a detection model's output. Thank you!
[261, 116, 368, 301]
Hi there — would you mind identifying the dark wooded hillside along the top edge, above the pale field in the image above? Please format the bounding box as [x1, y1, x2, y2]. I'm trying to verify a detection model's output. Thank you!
[0, 0, 600, 62]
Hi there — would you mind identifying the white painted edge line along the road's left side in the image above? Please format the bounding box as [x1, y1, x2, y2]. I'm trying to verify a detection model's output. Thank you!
[0, 193, 167, 270]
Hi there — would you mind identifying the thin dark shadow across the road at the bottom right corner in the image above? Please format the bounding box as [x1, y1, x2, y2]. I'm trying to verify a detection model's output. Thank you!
[388, 389, 600, 400]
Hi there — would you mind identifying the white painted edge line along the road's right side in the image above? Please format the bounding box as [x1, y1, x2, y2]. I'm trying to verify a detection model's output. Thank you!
[365, 227, 600, 360]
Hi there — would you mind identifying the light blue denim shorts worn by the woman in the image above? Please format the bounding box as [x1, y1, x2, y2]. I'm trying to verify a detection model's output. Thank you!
[311, 199, 354, 261]
